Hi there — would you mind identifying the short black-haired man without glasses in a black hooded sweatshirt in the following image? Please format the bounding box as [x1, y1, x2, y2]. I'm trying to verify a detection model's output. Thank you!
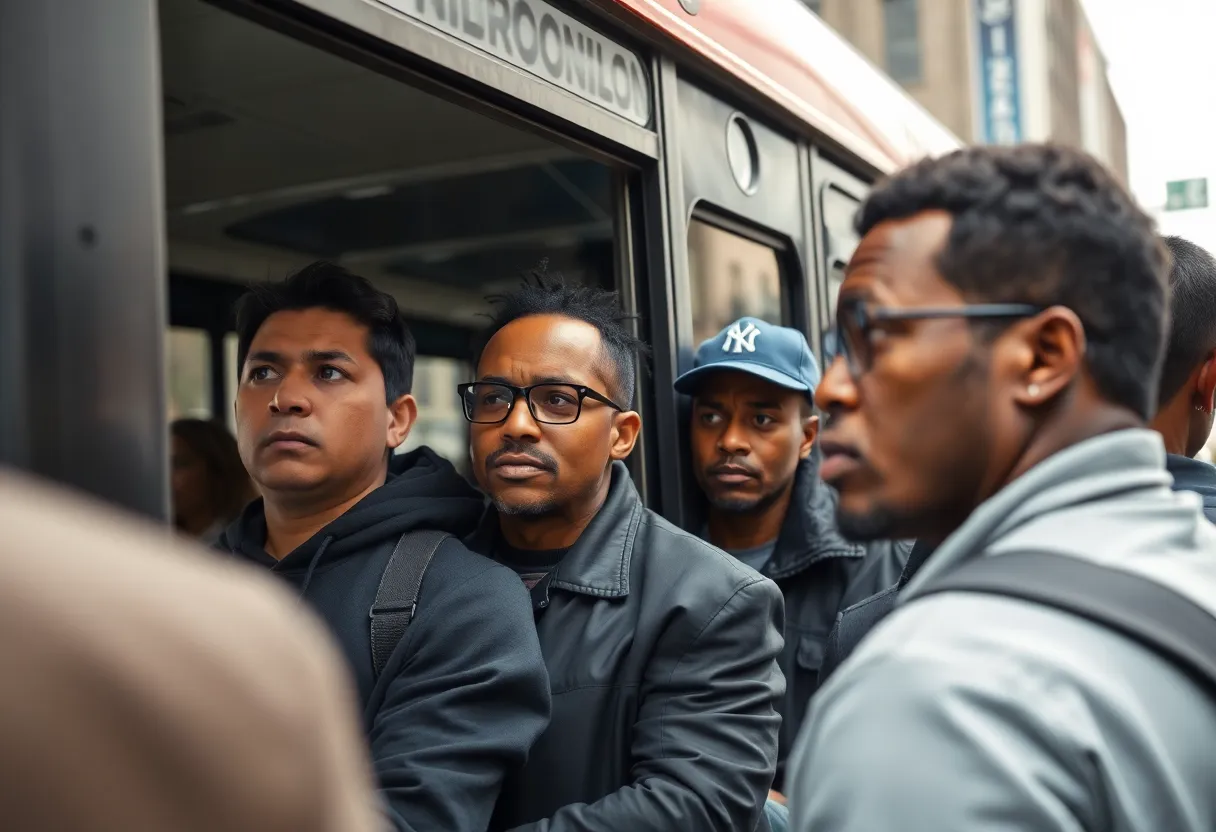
[221, 263, 550, 832]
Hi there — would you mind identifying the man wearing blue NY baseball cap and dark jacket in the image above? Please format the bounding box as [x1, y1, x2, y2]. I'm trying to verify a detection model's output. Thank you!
[675, 317, 911, 792]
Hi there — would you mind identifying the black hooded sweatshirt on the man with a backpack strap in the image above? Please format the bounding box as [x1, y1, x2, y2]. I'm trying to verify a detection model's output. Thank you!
[220, 448, 550, 832]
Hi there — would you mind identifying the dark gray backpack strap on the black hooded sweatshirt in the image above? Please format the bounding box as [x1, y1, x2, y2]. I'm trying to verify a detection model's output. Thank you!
[370, 532, 451, 678]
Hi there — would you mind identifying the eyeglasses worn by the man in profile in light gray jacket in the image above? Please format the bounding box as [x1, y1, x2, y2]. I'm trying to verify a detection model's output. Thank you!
[820, 298, 1042, 378]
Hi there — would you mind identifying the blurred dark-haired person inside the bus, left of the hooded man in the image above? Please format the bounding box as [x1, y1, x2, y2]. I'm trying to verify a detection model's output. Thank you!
[169, 418, 258, 545]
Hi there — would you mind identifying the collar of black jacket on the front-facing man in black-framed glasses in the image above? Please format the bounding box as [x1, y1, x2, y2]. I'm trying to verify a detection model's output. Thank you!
[468, 462, 646, 598]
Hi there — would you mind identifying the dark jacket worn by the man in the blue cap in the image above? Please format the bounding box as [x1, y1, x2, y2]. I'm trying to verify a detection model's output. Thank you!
[765, 450, 912, 791]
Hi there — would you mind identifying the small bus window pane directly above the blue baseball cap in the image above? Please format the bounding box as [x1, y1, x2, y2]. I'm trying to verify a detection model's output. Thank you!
[688, 218, 788, 344]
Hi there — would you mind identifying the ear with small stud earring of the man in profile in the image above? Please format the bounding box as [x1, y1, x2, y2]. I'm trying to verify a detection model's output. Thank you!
[1002, 307, 1086, 407]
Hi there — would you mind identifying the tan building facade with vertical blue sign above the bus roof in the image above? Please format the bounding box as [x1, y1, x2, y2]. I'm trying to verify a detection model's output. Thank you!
[803, 0, 1127, 182]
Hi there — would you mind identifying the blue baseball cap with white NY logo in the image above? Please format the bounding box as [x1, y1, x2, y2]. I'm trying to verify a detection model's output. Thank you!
[675, 317, 820, 397]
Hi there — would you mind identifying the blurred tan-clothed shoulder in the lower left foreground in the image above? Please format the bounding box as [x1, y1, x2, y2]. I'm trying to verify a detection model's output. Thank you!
[0, 471, 381, 832]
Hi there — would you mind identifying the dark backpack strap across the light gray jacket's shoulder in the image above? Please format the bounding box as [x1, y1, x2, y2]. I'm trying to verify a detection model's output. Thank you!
[908, 552, 1216, 693]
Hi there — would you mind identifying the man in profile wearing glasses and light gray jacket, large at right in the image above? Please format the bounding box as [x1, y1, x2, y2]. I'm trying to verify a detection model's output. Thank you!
[787, 146, 1216, 832]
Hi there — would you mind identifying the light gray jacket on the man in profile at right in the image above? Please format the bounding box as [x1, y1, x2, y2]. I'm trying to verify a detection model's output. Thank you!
[788, 429, 1216, 832]
